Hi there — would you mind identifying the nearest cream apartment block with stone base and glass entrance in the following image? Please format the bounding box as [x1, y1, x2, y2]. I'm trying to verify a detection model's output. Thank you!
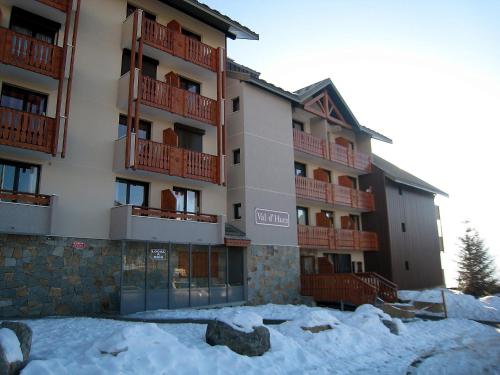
[0, 0, 258, 316]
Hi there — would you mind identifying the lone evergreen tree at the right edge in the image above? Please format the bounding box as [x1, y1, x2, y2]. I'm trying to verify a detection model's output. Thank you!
[458, 223, 498, 297]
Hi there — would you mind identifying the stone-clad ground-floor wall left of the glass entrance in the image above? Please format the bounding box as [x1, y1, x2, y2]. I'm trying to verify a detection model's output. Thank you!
[0, 234, 121, 318]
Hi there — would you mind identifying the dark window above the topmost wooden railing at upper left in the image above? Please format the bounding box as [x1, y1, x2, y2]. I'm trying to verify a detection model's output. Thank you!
[10, 7, 61, 44]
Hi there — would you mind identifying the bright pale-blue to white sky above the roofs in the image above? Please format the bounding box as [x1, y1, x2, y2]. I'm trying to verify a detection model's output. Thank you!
[204, 0, 500, 286]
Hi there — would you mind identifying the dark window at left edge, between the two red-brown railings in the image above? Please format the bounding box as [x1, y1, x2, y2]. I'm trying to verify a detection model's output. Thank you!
[0, 84, 48, 115]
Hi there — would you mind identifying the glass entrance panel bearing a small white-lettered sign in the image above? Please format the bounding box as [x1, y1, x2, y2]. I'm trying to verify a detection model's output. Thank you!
[146, 243, 169, 310]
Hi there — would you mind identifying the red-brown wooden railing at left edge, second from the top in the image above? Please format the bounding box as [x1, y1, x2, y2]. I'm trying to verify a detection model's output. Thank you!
[0, 107, 56, 153]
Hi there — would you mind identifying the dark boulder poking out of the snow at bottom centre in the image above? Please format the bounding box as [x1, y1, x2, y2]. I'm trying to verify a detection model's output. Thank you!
[205, 320, 271, 357]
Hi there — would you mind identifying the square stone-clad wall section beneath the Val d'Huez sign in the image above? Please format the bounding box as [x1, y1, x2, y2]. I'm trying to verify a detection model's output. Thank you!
[247, 245, 300, 305]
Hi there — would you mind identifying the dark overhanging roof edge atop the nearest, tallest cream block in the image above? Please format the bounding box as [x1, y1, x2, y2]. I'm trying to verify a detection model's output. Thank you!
[161, 0, 259, 40]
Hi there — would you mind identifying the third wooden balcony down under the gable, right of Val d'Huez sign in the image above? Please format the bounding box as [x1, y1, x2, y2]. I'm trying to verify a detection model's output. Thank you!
[297, 225, 378, 251]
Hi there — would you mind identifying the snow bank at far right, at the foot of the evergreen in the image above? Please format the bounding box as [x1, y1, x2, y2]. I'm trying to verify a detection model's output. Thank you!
[398, 289, 500, 322]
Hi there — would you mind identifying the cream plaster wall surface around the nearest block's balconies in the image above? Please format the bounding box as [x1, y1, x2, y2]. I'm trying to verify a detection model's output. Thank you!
[0, 0, 226, 238]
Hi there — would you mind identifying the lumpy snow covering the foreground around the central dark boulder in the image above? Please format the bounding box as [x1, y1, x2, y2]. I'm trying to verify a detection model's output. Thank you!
[11, 305, 500, 375]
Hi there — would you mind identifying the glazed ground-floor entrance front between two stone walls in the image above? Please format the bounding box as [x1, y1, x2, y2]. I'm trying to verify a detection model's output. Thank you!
[120, 242, 245, 314]
